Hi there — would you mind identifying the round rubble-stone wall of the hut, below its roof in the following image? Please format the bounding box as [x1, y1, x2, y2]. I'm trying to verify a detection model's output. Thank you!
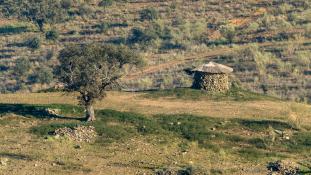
[193, 72, 230, 92]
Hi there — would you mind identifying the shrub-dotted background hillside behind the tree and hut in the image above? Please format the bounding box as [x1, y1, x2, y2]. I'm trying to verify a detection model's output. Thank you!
[0, 0, 311, 102]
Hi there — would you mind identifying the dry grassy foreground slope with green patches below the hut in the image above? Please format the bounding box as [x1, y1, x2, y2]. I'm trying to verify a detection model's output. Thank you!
[0, 90, 311, 175]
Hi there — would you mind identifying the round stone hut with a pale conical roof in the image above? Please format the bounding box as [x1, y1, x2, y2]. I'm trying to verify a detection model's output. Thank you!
[193, 62, 233, 92]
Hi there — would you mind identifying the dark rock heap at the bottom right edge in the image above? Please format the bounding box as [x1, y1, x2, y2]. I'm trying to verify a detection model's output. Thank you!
[267, 160, 299, 175]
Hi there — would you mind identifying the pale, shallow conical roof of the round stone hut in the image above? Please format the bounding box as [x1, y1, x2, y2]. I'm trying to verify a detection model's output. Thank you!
[193, 62, 233, 74]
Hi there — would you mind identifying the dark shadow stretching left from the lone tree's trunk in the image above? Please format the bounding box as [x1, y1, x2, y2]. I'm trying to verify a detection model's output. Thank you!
[0, 104, 85, 121]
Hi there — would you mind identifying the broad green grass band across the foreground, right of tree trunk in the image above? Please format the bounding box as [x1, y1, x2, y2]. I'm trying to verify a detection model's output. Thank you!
[25, 105, 311, 163]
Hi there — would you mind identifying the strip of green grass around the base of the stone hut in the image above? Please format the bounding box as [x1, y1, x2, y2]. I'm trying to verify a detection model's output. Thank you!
[144, 88, 277, 101]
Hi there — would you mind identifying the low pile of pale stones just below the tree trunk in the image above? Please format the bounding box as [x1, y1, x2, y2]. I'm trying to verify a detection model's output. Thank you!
[54, 126, 97, 142]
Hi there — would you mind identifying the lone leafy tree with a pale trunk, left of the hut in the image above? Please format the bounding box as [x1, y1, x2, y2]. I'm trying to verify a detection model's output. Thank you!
[55, 44, 143, 121]
